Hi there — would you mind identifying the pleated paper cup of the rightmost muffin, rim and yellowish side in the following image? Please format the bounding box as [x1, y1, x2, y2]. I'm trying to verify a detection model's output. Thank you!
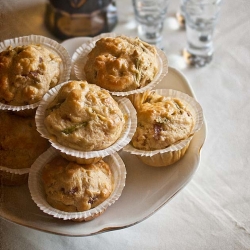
[123, 89, 204, 167]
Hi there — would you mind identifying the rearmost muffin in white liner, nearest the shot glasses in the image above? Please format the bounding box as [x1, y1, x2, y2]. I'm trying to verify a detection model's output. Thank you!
[72, 33, 168, 96]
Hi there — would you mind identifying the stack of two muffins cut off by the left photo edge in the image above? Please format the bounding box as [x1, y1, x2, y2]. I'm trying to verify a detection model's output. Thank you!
[0, 36, 71, 185]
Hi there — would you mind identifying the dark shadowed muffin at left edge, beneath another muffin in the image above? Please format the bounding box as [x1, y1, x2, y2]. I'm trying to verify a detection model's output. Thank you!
[0, 111, 50, 185]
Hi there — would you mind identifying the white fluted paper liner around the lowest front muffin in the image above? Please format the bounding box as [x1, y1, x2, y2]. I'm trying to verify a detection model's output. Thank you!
[28, 147, 127, 221]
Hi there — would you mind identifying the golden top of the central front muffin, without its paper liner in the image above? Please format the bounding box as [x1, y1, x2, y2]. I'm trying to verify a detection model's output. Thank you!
[44, 81, 125, 151]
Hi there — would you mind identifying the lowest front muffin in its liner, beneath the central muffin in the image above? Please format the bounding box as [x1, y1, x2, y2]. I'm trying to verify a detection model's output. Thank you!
[28, 147, 126, 222]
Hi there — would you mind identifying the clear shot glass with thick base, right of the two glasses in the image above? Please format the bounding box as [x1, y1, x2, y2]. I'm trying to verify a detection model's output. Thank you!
[184, 0, 222, 67]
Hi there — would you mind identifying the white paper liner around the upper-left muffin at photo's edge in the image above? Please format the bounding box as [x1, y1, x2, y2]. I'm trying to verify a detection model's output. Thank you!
[0, 35, 71, 111]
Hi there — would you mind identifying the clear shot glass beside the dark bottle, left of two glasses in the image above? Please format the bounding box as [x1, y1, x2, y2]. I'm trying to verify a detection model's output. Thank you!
[133, 0, 169, 47]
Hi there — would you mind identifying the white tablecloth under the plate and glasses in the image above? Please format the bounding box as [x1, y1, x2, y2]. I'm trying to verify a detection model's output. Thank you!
[0, 0, 250, 250]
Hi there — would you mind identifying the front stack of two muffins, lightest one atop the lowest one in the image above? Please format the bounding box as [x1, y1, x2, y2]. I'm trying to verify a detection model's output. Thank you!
[32, 80, 136, 221]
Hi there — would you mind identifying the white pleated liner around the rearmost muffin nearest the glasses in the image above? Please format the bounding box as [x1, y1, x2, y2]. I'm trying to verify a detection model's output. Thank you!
[72, 33, 168, 96]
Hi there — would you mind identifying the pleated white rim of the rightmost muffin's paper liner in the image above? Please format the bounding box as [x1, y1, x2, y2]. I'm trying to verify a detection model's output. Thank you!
[123, 89, 203, 157]
